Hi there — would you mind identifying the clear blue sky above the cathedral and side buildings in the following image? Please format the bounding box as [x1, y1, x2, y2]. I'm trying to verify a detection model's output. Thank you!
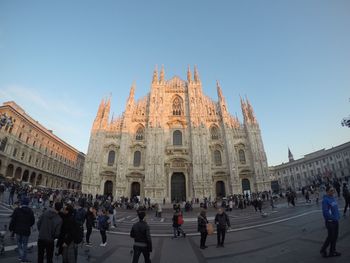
[0, 0, 350, 165]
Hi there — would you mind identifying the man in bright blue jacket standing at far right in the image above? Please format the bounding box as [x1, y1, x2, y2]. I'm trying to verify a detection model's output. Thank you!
[320, 186, 341, 257]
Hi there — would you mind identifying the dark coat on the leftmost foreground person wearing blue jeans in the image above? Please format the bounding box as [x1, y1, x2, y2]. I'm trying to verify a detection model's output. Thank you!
[9, 206, 35, 236]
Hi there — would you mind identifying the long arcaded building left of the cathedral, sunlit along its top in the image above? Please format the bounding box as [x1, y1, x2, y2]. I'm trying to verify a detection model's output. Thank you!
[0, 101, 85, 190]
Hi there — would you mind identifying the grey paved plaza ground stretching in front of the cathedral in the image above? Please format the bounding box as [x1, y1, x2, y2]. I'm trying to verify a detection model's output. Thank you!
[0, 195, 350, 263]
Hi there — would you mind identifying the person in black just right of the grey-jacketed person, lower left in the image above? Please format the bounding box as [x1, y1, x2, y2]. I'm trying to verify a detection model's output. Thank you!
[57, 204, 82, 263]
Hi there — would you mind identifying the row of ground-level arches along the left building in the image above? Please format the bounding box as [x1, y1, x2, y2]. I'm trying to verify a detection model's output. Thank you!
[0, 160, 79, 190]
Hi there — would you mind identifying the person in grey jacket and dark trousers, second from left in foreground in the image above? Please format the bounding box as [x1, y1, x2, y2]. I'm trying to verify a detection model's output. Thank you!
[37, 203, 62, 263]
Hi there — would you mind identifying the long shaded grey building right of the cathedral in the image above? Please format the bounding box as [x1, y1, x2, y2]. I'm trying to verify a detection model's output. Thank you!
[270, 142, 350, 189]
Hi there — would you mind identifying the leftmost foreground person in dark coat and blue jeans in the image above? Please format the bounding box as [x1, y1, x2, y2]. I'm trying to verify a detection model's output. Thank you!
[9, 197, 35, 263]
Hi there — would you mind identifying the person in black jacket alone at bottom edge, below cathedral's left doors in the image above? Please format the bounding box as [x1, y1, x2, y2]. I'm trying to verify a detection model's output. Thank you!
[130, 210, 152, 263]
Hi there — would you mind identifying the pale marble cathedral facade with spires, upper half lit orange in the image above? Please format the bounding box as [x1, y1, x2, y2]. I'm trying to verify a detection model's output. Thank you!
[82, 68, 271, 202]
